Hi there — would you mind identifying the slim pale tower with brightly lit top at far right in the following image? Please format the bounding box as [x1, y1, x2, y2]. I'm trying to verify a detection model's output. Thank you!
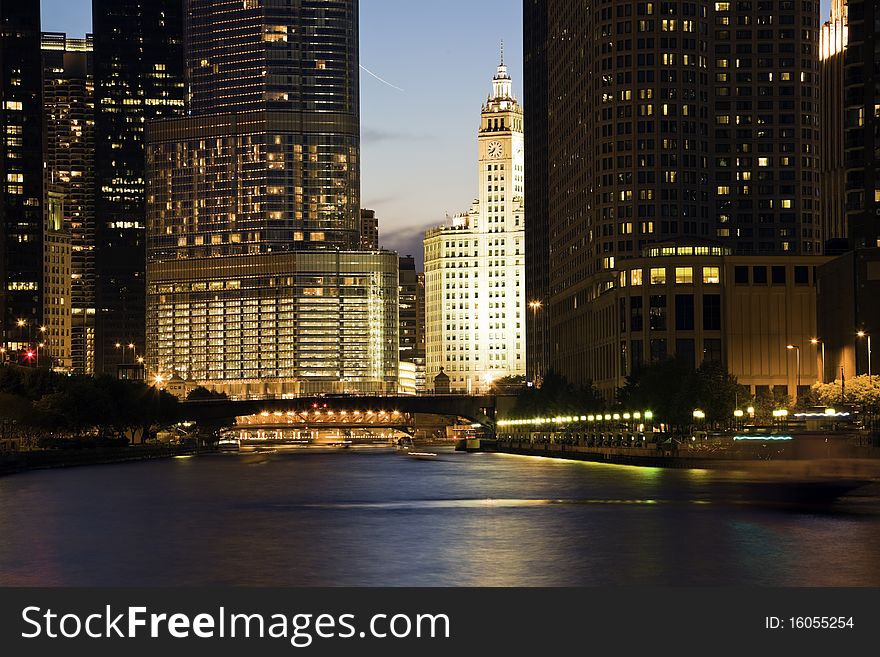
[819, 0, 848, 253]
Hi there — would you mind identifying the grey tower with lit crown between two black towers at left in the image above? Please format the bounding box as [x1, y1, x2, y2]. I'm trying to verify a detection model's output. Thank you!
[43, 32, 95, 374]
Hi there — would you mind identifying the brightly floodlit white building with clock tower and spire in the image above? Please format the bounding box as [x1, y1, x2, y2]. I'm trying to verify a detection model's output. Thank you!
[425, 57, 526, 393]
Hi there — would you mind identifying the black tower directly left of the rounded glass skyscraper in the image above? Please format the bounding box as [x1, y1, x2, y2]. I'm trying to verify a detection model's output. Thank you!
[92, 0, 186, 374]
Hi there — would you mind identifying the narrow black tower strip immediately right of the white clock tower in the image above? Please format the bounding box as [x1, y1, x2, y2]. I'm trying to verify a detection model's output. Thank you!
[523, 0, 550, 382]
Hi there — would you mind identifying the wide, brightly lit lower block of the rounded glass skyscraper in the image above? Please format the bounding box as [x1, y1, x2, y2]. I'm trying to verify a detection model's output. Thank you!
[147, 250, 398, 398]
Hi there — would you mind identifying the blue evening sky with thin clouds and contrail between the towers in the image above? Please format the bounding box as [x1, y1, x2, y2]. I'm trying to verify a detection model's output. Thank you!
[41, 0, 830, 261]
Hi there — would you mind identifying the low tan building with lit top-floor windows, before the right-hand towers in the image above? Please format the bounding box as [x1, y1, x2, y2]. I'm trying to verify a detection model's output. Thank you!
[596, 240, 829, 399]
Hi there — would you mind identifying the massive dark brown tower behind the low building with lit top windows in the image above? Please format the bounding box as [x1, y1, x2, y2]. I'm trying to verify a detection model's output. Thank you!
[524, 0, 822, 395]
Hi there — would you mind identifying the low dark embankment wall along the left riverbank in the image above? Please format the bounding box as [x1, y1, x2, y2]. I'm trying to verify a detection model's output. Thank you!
[0, 445, 196, 476]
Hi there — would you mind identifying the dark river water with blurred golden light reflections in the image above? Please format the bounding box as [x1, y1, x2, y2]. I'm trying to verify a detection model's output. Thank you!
[0, 451, 880, 586]
